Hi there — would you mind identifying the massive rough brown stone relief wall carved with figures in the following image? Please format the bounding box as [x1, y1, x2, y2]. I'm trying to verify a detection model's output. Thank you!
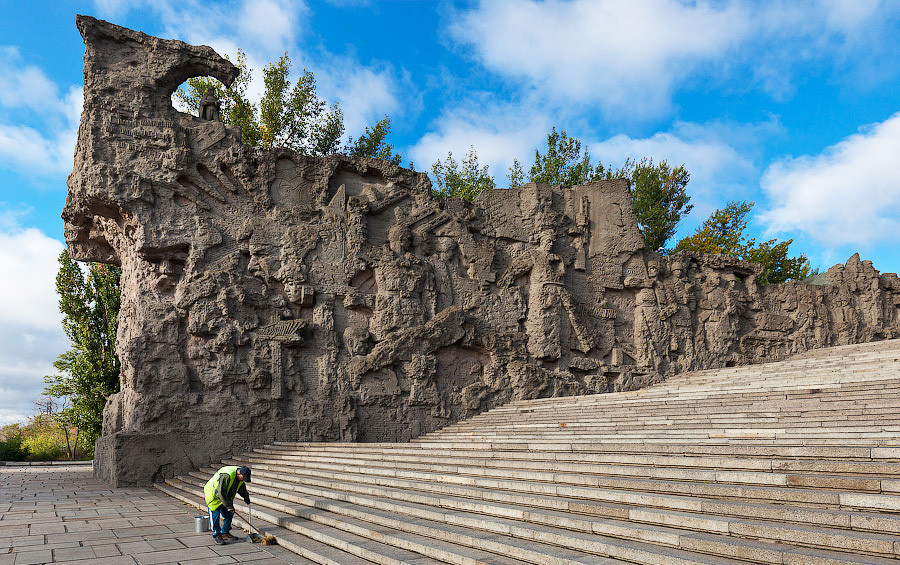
[63, 17, 900, 485]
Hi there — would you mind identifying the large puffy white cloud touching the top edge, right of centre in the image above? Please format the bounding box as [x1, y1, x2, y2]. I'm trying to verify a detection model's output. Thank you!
[451, 0, 750, 114]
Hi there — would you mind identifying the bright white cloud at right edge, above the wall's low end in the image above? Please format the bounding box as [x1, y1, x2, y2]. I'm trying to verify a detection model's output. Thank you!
[760, 113, 900, 246]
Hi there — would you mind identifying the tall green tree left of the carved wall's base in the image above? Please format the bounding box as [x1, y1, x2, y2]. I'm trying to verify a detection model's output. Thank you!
[44, 251, 121, 451]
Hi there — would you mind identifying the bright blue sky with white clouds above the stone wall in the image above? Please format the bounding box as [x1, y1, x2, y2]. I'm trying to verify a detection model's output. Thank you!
[0, 0, 900, 425]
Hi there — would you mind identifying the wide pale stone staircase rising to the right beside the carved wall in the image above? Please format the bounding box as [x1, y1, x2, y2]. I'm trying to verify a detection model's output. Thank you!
[157, 340, 900, 565]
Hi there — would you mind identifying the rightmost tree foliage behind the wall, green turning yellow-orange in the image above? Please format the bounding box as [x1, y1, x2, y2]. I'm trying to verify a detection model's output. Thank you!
[675, 200, 810, 284]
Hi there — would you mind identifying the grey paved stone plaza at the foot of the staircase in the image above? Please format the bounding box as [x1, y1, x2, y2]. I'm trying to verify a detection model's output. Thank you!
[0, 465, 308, 565]
